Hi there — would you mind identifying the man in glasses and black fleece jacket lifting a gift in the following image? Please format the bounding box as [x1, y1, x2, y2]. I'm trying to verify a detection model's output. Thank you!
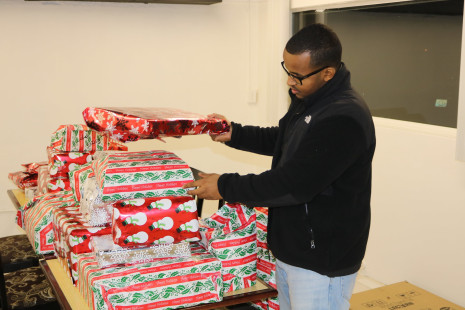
[186, 24, 376, 310]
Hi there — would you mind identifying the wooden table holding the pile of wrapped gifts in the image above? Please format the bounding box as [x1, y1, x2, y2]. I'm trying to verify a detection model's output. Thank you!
[7, 189, 278, 310]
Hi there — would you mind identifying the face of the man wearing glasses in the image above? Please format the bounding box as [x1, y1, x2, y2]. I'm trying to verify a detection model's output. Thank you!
[283, 50, 334, 99]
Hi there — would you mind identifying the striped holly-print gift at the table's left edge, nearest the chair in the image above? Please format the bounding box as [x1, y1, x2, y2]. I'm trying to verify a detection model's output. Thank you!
[22, 191, 74, 254]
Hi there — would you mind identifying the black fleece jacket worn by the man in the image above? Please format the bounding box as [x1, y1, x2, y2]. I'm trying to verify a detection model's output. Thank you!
[218, 65, 376, 277]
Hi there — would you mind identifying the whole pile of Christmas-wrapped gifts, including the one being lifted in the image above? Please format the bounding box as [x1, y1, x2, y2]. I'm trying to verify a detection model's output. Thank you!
[10, 108, 278, 309]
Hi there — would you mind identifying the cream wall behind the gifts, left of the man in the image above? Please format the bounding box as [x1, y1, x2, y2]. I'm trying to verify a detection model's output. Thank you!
[0, 0, 282, 236]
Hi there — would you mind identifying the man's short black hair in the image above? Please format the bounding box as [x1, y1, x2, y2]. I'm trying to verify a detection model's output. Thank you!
[286, 23, 342, 68]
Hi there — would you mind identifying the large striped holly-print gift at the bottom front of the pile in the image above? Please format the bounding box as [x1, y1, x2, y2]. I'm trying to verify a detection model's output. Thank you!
[78, 245, 223, 310]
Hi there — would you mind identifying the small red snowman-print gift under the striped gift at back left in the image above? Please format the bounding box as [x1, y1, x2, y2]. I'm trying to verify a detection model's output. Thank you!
[47, 147, 95, 178]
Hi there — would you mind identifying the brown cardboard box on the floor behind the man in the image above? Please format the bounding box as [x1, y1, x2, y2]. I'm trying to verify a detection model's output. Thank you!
[350, 281, 465, 310]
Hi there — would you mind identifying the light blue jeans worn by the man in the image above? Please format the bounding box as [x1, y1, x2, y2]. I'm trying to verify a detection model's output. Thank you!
[276, 260, 357, 310]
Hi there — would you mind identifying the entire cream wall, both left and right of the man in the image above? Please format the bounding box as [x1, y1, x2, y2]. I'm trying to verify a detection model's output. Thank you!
[0, 0, 465, 306]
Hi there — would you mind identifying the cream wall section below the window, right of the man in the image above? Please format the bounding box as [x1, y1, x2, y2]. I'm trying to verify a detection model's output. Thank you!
[364, 118, 465, 306]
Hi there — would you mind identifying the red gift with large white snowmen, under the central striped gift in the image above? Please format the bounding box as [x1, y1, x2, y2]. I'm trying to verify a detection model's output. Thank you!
[112, 196, 200, 247]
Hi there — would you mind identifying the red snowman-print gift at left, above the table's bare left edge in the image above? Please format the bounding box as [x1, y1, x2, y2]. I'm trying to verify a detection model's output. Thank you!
[52, 206, 111, 282]
